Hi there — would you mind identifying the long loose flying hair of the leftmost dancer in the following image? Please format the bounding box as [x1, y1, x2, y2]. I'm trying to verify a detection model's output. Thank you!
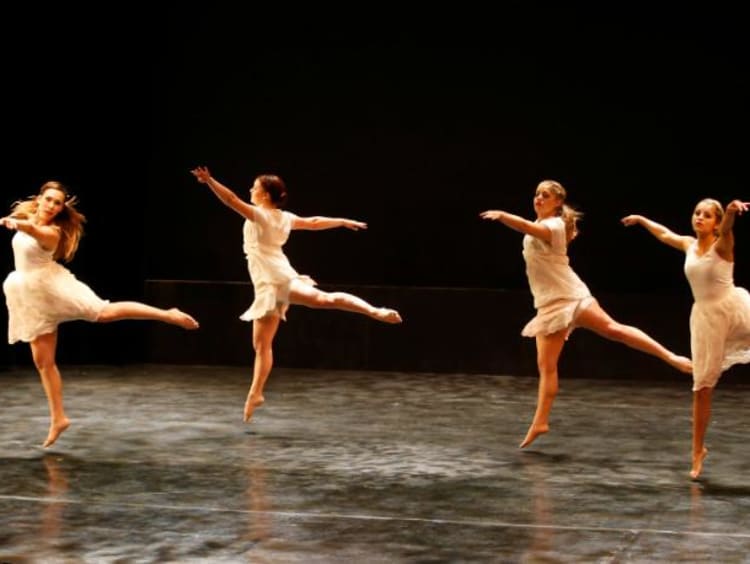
[10, 180, 86, 262]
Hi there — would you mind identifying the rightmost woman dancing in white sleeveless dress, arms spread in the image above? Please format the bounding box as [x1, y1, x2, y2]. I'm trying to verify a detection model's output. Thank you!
[622, 198, 750, 479]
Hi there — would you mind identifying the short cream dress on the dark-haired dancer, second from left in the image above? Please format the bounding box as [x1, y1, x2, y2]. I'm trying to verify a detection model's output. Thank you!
[240, 206, 310, 321]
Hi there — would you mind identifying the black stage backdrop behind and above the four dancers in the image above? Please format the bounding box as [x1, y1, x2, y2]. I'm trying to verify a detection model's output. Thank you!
[0, 7, 750, 374]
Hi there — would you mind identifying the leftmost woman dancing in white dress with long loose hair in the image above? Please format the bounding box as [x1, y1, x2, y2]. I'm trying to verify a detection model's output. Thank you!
[0, 181, 198, 447]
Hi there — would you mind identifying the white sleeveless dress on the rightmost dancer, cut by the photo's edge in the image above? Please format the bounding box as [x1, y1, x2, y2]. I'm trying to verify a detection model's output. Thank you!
[685, 241, 750, 391]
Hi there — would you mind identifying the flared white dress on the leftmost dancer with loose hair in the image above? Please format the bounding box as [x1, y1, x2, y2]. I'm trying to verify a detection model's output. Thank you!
[3, 231, 109, 344]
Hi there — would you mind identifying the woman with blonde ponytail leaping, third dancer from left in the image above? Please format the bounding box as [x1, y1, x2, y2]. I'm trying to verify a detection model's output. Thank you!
[480, 180, 691, 448]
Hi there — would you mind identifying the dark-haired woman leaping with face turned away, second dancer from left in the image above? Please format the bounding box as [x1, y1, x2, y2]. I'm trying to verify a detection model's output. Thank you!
[191, 166, 401, 421]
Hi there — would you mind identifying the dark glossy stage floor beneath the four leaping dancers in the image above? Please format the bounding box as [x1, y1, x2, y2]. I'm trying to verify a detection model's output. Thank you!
[0, 366, 750, 563]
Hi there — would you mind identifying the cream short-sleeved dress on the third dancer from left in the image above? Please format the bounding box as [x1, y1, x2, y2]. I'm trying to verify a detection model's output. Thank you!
[521, 217, 595, 339]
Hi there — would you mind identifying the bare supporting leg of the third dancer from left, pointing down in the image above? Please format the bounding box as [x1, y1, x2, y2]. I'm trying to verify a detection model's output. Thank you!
[519, 329, 567, 448]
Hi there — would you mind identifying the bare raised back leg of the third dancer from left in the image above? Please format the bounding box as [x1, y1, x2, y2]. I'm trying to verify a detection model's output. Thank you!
[576, 303, 693, 374]
